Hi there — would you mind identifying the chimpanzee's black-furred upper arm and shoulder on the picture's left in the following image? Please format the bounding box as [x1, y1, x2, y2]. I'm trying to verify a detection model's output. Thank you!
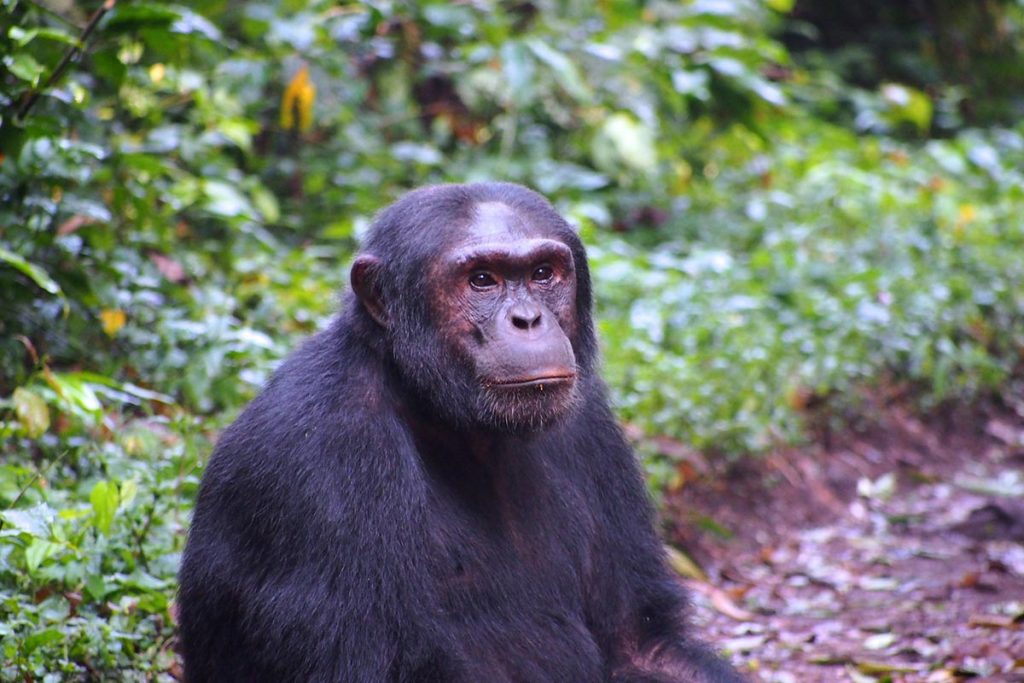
[178, 344, 456, 683]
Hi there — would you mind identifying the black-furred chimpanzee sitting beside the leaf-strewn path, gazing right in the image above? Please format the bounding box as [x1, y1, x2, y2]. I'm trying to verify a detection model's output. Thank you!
[178, 182, 741, 683]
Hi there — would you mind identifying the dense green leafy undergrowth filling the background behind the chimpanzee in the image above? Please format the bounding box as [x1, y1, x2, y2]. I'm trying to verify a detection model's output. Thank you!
[0, 0, 1024, 680]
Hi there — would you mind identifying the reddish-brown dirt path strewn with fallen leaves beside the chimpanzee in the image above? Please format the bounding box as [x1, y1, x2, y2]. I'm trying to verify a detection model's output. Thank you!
[666, 400, 1024, 683]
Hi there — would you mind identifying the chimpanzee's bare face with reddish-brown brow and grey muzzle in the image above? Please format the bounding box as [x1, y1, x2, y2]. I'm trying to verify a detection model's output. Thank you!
[429, 198, 578, 431]
